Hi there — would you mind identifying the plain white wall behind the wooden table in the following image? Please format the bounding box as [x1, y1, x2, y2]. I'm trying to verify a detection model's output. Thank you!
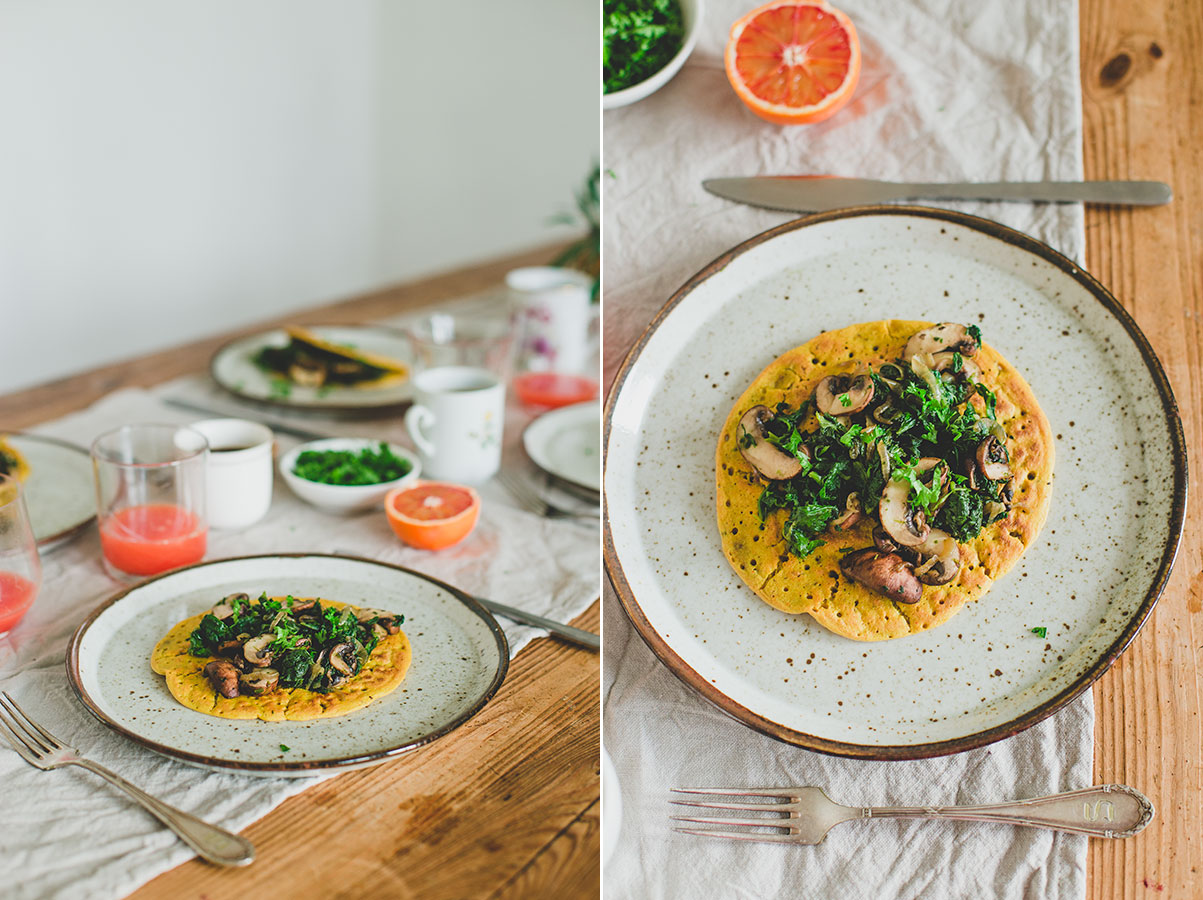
[0, 0, 599, 392]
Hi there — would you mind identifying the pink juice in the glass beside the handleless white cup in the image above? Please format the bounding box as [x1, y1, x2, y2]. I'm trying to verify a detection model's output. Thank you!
[100, 503, 209, 575]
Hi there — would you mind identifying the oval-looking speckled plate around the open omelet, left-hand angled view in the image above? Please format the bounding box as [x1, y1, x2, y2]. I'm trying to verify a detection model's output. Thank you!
[67, 555, 509, 776]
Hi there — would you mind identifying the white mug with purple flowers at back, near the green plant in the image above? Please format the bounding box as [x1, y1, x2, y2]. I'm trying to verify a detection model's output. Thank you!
[505, 266, 598, 374]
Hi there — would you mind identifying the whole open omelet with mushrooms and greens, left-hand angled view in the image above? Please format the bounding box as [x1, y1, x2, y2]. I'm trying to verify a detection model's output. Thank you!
[150, 593, 410, 722]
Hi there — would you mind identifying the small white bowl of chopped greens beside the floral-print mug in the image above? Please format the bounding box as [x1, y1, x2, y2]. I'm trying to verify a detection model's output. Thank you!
[279, 438, 421, 514]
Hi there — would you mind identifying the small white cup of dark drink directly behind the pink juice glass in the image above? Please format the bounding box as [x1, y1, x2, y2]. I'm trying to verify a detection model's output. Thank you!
[191, 419, 274, 529]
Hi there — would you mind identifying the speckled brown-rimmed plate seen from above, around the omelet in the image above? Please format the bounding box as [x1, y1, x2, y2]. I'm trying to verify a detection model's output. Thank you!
[604, 207, 1186, 759]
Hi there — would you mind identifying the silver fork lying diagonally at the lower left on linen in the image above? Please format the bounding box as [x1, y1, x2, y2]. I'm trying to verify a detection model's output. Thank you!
[0, 691, 255, 865]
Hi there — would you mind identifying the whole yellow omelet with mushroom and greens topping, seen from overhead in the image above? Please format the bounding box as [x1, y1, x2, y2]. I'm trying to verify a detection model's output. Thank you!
[716, 320, 1054, 640]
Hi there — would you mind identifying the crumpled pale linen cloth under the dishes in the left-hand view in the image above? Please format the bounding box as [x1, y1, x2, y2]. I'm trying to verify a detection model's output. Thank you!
[0, 378, 599, 900]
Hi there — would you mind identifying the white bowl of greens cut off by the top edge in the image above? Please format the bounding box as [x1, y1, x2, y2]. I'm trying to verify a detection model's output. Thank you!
[602, 0, 703, 109]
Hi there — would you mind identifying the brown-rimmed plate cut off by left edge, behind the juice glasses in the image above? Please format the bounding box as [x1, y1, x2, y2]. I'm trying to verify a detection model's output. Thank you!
[7, 432, 96, 553]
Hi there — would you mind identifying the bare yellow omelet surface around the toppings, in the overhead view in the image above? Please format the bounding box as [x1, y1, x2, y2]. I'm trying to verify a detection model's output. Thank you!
[716, 319, 1054, 640]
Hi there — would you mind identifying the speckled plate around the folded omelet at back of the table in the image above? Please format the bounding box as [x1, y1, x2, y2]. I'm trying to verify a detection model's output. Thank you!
[209, 325, 413, 415]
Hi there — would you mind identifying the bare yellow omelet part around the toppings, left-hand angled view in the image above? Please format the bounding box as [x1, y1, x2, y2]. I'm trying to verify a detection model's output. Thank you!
[150, 597, 411, 722]
